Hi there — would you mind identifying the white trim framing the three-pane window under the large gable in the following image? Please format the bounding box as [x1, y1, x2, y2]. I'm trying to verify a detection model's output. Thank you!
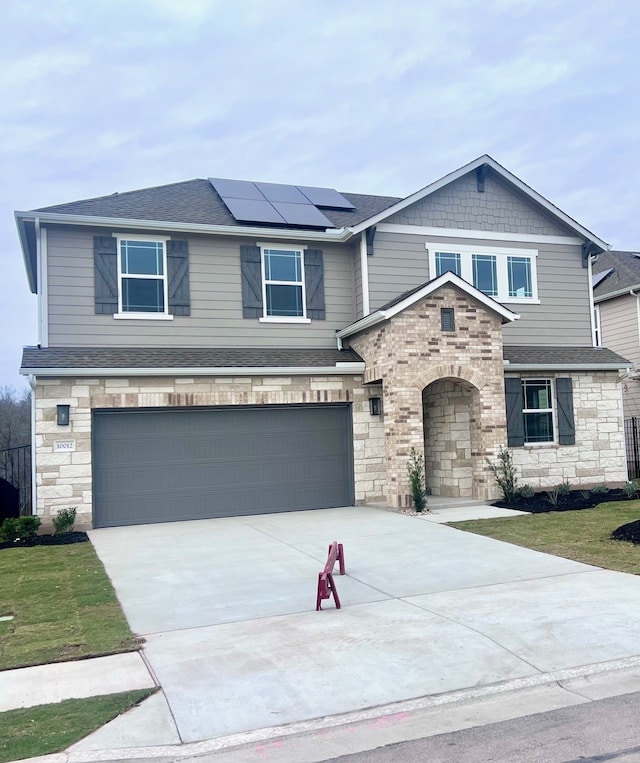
[425, 242, 540, 305]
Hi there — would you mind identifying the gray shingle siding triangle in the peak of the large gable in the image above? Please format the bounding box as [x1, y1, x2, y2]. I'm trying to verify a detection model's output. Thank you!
[384, 172, 575, 236]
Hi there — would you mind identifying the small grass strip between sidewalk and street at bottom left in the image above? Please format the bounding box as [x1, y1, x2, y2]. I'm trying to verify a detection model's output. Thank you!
[0, 692, 155, 763]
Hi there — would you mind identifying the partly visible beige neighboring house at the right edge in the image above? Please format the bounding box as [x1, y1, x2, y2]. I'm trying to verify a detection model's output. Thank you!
[592, 251, 640, 418]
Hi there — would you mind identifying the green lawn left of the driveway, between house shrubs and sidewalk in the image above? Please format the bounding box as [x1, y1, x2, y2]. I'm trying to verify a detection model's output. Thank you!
[0, 543, 137, 672]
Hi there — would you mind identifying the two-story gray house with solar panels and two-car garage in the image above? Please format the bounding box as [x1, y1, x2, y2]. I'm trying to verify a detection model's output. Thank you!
[16, 156, 629, 527]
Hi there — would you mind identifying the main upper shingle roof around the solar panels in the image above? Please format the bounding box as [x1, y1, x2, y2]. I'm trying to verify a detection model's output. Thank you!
[33, 179, 400, 228]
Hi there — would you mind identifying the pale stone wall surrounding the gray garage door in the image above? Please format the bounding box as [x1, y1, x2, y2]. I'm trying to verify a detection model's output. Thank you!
[35, 376, 386, 527]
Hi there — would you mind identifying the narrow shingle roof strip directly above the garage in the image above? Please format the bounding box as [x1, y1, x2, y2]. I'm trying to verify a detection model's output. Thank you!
[22, 347, 362, 371]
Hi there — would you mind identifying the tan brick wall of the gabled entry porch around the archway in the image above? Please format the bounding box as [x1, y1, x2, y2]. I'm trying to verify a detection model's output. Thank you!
[349, 286, 506, 506]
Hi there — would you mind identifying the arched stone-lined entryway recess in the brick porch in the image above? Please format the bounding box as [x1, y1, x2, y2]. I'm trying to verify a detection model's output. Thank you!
[422, 377, 483, 498]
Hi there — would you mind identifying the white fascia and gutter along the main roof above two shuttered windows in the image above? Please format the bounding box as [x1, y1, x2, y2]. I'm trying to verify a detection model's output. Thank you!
[15, 212, 352, 242]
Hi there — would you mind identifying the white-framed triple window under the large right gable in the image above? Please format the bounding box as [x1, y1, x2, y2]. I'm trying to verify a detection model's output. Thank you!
[426, 244, 538, 302]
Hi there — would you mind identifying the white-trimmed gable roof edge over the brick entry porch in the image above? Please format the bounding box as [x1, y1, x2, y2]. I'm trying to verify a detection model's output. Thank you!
[336, 271, 520, 340]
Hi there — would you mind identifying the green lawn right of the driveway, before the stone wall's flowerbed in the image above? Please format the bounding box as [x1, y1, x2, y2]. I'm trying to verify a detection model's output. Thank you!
[450, 501, 640, 575]
